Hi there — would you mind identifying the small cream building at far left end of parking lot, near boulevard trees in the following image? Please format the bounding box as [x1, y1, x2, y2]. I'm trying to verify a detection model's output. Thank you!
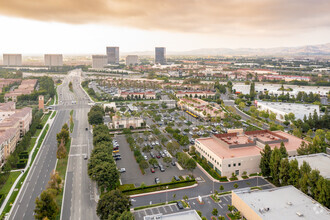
[109, 115, 144, 129]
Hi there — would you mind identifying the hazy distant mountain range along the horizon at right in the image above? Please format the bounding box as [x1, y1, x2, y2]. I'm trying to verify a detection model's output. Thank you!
[124, 43, 330, 56]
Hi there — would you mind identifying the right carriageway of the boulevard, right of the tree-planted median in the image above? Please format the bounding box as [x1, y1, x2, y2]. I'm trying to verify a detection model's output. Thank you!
[61, 70, 98, 220]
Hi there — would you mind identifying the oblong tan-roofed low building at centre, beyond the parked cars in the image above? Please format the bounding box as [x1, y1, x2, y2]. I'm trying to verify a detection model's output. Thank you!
[177, 98, 224, 119]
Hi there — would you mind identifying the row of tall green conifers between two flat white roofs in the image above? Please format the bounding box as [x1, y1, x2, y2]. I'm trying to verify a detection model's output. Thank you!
[259, 142, 330, 208]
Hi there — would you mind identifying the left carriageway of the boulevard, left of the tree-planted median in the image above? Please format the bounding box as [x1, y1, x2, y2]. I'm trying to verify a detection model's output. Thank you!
[9, 73, 73, 219]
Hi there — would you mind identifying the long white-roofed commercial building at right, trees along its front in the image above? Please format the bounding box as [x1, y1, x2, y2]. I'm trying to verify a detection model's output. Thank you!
[255, 100, 320, 121]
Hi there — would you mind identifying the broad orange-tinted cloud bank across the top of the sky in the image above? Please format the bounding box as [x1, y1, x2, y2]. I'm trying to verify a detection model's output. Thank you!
[0, 0, 330, 36]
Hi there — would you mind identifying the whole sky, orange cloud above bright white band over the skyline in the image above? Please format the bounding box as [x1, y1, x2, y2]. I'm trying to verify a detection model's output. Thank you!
[0, 0, 330, 54]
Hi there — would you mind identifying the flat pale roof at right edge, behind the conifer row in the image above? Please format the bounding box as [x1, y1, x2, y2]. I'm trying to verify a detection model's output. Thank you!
[290, 153, 330, 179]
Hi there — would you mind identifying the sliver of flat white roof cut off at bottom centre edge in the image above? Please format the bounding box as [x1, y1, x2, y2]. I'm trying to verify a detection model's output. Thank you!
[144, 209, 201, 220]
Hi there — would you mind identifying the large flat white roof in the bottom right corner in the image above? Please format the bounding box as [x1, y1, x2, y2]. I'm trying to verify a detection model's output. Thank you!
[234, 186, 330, 220]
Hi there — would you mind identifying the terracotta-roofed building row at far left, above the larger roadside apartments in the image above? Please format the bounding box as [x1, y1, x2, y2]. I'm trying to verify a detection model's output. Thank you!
[4, 79, 38, 102]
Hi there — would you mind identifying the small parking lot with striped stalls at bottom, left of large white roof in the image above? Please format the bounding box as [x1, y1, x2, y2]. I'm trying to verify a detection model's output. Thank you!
[134, 195, 231, 220]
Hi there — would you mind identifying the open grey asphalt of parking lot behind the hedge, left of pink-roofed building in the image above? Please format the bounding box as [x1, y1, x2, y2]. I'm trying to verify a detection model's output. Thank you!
[114, 135, 189, 186]
